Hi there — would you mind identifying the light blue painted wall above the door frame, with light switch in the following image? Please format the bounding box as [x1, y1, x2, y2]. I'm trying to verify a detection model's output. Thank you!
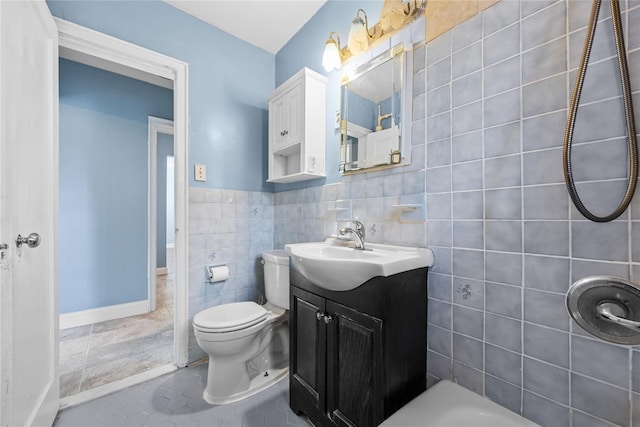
[47, 0, 275, 192]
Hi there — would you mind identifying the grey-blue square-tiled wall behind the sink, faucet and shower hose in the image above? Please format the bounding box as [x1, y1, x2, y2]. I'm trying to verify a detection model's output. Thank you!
[266, 0, 640, 426]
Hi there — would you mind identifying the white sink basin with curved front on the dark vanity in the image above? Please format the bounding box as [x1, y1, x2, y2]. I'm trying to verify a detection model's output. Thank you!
[284, 240, 433, 291]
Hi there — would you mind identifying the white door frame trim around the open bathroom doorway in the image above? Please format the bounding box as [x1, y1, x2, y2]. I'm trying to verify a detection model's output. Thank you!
[56, 19, 188, 406]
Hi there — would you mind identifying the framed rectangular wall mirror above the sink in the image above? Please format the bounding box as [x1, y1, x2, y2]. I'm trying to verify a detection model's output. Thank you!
[338, 45, 413, 174]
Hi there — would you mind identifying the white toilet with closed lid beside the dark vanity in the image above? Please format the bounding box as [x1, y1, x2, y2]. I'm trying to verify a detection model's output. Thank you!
[193, 250, 289, 405]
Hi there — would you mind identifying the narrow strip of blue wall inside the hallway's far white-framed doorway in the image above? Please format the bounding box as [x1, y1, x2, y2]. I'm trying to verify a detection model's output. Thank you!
[156, 133, 173, 267]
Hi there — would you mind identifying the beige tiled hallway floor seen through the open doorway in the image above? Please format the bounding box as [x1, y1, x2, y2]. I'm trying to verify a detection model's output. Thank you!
[60, 274, 175, 398]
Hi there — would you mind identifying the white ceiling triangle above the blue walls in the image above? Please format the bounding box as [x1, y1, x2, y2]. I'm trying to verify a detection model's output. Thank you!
[164, 0, 326, 54]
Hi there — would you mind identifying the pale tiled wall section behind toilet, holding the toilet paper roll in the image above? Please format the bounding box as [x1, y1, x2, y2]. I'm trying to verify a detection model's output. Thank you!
[189, 188, 274, 361]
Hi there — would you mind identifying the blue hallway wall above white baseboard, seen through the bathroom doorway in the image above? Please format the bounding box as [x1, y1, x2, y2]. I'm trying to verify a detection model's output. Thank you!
[60, 60, 173, 313]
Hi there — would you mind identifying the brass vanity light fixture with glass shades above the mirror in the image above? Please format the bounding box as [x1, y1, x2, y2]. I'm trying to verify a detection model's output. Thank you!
[322, 0, 427, 72]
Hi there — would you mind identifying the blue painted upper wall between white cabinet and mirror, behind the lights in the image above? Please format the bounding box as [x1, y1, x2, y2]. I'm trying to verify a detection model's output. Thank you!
[275, 0, 382, 192]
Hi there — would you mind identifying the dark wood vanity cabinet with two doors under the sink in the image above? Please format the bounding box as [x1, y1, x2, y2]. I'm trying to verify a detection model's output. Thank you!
[289, 267, 427, 427]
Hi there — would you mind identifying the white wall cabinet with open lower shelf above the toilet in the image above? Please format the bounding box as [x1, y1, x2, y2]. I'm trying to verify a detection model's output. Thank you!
[268, 68, 327, 183]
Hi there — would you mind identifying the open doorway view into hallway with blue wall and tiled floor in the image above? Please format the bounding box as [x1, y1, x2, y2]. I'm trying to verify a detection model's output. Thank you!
[59, 58, 175, 398]
